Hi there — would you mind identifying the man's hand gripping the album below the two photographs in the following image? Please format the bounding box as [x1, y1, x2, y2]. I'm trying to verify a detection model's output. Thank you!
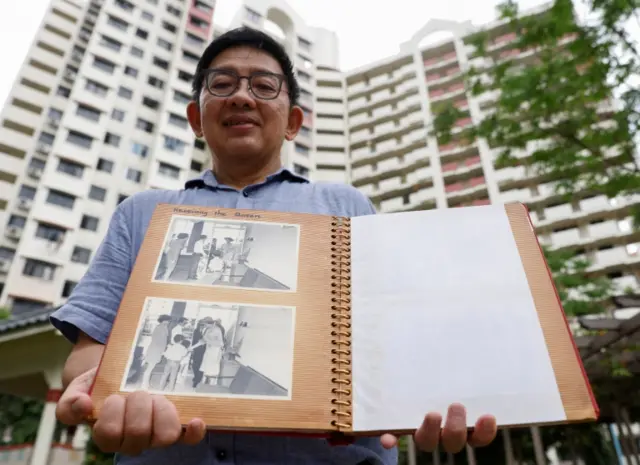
[56, 368, 206, 455]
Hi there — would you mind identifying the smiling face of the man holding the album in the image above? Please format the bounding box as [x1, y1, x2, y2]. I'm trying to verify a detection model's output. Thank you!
[190, 46, 301, 163]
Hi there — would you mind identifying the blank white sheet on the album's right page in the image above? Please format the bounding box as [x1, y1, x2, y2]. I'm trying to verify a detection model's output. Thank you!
[351, 205, 566, 431]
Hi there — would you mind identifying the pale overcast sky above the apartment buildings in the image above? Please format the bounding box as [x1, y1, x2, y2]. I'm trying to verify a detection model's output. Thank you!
[0, 0, 636, 104]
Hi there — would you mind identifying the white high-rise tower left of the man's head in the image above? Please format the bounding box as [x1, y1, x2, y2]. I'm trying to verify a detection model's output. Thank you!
[0, 0, 215, 312]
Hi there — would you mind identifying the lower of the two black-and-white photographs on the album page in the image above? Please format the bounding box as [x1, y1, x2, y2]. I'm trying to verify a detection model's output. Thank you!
[121, 298, 295, 400]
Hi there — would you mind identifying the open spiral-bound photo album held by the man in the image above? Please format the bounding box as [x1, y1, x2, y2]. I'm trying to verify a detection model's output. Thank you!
[91, 203, 598, 435]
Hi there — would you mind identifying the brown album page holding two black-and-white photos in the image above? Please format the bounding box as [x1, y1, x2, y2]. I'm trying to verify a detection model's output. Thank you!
[92, 205, 334, 432]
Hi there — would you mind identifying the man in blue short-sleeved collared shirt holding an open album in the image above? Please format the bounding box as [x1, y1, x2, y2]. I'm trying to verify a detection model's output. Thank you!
[52, 29, 496, 465]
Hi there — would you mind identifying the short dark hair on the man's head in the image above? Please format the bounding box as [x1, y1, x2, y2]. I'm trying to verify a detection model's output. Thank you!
[192, 26, 300, 106]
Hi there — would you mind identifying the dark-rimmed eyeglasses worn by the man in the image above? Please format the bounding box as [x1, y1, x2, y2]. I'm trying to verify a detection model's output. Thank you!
[203, 69, 284, 100]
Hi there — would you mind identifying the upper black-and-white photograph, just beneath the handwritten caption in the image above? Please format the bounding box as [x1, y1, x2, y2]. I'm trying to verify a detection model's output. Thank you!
[154, 216, 300, 292]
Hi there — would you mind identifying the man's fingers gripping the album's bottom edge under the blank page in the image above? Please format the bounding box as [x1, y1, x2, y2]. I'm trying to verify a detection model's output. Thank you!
[380, 404, 498, 454]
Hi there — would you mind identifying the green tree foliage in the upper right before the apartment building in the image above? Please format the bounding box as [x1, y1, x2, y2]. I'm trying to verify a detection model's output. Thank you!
[433, 0, 640, 225]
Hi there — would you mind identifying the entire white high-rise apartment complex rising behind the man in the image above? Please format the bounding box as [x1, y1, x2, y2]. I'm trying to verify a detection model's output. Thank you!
[0, 0, 640, 311]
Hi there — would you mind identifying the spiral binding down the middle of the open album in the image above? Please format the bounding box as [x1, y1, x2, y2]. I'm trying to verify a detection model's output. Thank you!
[331, 216, 351, 431]
